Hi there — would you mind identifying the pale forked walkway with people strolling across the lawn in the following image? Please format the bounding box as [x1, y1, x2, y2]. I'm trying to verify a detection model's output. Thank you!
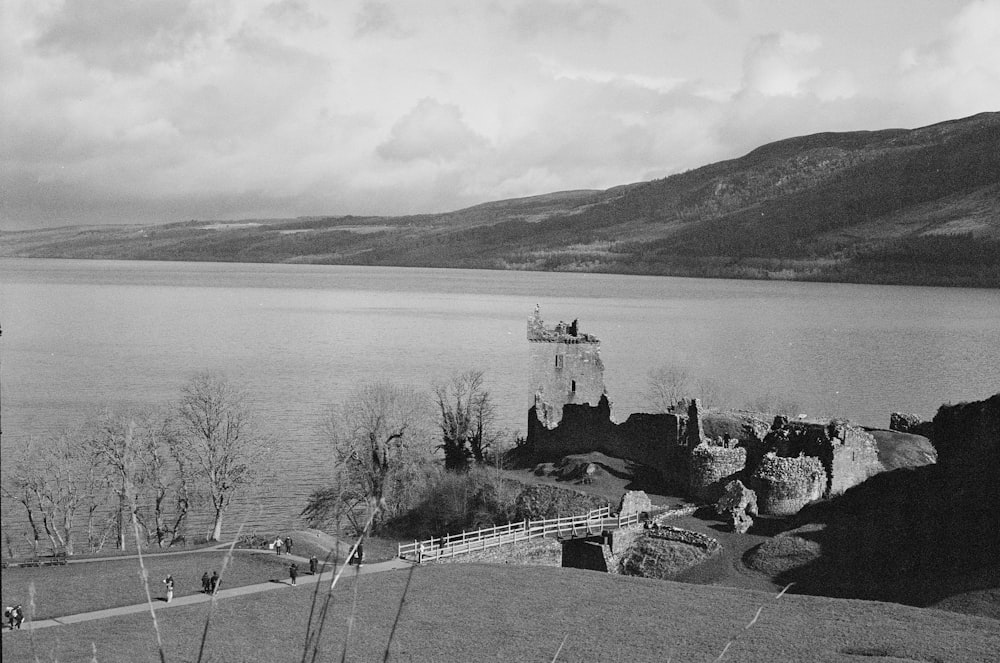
[4, 544, 413, 633]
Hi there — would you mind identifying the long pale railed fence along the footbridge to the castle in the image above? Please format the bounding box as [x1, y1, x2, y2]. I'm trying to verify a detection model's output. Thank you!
[399, 506, 639, 564]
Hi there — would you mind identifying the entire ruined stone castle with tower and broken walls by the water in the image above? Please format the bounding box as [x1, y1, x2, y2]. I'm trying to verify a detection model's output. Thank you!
[526, 307, 884, 515]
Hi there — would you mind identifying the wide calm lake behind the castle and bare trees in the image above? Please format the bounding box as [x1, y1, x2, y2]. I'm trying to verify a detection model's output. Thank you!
[0, 259, 1000, 538]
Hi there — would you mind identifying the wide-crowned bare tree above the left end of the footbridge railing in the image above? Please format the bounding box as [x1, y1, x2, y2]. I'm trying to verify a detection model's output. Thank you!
[318, 382, 432, 528]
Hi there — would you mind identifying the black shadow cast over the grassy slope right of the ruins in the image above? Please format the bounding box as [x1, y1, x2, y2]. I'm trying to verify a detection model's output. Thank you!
[776, 465, 1000, 607]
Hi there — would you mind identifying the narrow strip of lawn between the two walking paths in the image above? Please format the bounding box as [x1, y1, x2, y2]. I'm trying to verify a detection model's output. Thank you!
[2, 550, 294, 619]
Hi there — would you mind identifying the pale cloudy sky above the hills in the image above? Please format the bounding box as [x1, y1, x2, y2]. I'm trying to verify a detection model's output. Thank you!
[0, 0, 1000, 230]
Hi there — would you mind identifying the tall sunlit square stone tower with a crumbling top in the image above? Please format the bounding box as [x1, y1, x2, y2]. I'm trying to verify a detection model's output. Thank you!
[528, 306, 605, 428]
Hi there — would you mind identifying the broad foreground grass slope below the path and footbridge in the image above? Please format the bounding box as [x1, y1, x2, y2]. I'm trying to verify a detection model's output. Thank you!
[3, 564, 1000, 663]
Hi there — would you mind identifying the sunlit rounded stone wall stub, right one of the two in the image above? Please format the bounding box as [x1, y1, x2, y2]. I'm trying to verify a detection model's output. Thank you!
[750, 453, 827, 516]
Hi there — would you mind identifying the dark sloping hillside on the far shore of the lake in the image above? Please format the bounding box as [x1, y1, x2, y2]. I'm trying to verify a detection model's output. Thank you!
[0, 113, 1000, 287]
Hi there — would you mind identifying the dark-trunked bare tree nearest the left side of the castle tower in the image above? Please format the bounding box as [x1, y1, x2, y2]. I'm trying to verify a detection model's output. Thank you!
[434, 371, 500, 471]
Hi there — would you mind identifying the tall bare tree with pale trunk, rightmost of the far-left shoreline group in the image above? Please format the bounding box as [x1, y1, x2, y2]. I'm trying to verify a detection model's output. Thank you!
[177, 372, 267, 541]
